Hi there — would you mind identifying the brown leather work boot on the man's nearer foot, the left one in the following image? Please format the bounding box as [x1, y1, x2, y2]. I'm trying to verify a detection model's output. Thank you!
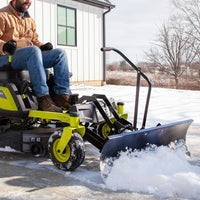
[38, 95, 62, 112]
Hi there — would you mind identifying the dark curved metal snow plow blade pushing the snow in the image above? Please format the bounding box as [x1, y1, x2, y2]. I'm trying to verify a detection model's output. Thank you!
[100, 119, 193, 161]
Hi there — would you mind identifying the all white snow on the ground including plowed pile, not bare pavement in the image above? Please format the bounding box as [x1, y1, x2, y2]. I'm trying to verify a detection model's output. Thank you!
[0, 85, 200, 200]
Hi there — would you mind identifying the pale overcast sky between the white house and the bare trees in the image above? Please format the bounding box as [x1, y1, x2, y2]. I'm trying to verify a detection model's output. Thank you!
[106, 0, 172, 63]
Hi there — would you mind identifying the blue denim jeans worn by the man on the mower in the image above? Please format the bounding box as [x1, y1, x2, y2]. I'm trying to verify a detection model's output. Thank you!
[0, 46, 70, 97]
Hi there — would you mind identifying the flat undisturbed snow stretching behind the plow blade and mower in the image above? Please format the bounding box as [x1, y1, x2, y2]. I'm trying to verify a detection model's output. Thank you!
[72, 85, 200, 127]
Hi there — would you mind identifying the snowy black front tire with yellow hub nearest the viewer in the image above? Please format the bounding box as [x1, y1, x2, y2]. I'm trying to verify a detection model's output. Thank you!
[48, 129, 85, 171]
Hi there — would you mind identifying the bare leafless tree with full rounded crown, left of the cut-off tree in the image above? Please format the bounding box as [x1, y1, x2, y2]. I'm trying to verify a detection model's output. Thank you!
[146, 21, 196, 89]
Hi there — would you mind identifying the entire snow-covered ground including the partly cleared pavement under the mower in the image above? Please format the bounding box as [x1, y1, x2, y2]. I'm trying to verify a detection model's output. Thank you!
[0, 85, 200, 200]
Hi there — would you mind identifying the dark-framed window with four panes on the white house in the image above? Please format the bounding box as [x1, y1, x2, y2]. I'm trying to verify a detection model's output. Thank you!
[57, 6, 76, 46]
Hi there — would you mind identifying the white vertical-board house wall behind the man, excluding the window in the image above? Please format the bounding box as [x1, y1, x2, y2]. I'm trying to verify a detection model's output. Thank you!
[0, 0, 103, 85]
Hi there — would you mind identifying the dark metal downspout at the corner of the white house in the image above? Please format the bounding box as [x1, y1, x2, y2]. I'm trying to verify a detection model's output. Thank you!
[103, 7, 111, 85]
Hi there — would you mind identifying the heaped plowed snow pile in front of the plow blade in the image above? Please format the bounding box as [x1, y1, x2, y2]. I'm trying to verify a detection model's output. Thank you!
[101, 143, 200, 199]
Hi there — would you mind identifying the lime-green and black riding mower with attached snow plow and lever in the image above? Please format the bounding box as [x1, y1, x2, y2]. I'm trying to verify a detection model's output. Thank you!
[0, 48, 192, 171]
